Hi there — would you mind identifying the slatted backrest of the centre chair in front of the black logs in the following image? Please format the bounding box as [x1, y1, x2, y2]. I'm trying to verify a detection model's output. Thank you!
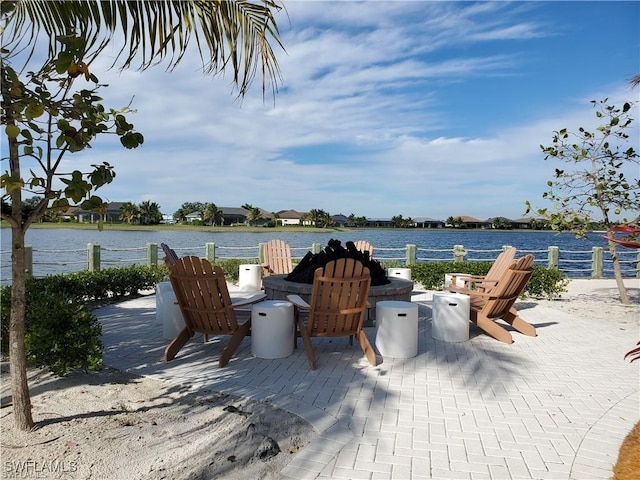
[307, 258, 371, 337]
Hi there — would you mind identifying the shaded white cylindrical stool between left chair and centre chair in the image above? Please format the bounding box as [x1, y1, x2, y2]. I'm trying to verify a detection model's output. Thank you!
[251, 300, 294, 358]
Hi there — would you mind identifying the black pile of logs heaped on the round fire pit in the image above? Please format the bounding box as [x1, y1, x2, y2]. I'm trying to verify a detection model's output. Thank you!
[285, 240, 391, 287]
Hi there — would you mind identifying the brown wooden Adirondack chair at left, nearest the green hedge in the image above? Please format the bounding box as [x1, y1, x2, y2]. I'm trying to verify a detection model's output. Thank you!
[164, 256, 266, 367]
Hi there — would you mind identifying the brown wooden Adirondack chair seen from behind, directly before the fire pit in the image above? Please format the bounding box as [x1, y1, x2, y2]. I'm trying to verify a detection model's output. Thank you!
[287, 258, 377, 370]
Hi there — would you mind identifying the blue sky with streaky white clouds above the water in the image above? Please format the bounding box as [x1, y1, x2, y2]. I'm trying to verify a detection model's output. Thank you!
[3, 0, 640, 219]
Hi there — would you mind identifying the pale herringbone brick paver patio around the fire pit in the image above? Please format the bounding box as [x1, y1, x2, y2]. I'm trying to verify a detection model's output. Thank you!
[97, 282, 640, 480]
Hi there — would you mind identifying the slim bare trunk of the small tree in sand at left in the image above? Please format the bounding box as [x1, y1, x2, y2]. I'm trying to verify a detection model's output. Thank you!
[9, 223, 33, 430]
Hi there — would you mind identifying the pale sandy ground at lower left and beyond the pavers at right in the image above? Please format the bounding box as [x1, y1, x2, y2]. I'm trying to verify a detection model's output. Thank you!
[0, 280, 640, 480]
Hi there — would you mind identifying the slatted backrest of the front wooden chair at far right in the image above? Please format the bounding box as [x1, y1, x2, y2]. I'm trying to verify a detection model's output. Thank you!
[470, 255, 533, 319]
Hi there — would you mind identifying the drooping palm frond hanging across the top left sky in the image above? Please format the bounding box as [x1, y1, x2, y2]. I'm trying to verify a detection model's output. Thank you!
[0, 0, 284, 96]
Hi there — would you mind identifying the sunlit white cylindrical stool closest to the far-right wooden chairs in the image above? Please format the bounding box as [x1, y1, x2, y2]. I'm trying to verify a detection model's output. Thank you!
[431, 292, 470, 342]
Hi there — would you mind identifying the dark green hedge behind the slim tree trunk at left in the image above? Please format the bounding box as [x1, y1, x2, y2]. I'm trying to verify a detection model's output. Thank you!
[0, 265, 168, 375]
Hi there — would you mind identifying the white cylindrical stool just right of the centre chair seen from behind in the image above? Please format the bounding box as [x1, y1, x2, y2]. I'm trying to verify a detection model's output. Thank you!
[375, 300, 418, 358]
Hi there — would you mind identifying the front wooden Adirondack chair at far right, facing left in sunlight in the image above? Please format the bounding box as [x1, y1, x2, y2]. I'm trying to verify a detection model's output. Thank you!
[467, 255, 536, 343]
